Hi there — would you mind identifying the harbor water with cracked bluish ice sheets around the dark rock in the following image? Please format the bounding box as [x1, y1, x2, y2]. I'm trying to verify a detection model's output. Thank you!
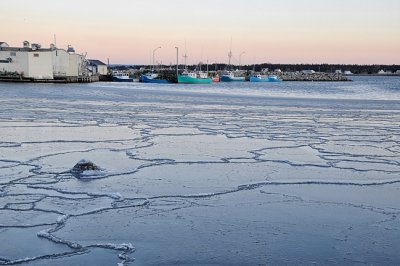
[0, 77, 400, 265]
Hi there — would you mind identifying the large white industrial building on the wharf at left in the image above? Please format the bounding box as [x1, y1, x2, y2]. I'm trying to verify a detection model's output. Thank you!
[0, 41, 87, 80]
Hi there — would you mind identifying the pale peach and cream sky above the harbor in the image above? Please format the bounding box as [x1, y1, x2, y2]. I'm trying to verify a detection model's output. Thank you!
[0, 0, 400, 64]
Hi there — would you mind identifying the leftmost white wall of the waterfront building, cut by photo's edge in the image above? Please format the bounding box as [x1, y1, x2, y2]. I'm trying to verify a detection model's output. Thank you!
[0, 50, 29, 76]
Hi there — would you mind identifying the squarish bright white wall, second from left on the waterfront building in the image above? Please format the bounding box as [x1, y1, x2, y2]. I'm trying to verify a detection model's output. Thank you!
[28, 51, 53, 79]
